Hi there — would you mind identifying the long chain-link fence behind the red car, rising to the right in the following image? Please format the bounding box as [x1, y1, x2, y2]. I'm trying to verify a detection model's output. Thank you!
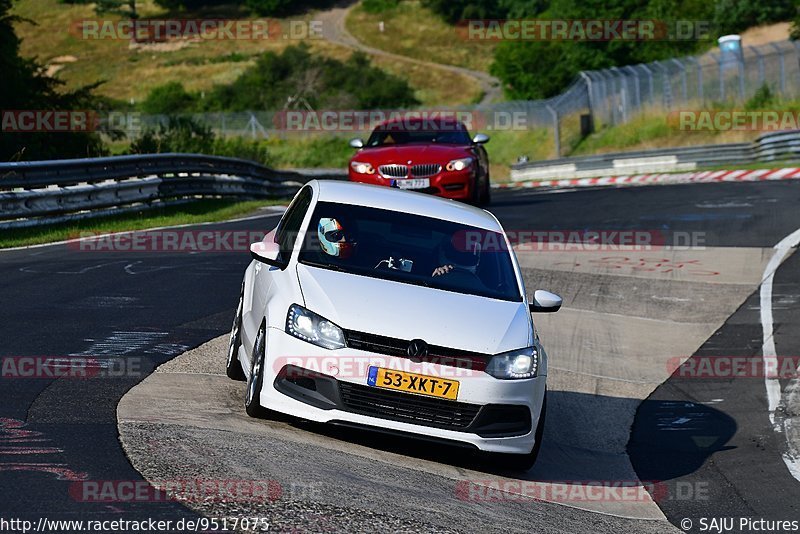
[142, 41, 800, 157]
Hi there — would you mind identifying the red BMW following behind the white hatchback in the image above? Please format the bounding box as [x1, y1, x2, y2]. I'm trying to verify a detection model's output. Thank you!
[348, 118, 491, 206]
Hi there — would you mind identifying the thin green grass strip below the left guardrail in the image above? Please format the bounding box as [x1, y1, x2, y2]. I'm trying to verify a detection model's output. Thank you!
[0, 199, 288, 249]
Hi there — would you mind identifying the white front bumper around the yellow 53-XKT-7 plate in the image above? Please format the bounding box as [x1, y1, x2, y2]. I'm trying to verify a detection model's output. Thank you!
[253, 328, 546, 454]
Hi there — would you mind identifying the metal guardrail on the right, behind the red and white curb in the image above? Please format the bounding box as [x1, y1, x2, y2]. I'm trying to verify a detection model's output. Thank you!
[511, 131, 800, 182]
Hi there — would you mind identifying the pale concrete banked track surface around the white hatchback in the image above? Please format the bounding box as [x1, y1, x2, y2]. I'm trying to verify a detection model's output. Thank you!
[117, 247, 780, 532]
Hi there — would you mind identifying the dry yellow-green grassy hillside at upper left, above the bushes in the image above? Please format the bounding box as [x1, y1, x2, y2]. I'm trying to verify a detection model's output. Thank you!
[14, 0, 480, 106]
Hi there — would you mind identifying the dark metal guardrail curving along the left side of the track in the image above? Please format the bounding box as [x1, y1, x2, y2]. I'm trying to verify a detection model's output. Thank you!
[0, 154, 346, 228]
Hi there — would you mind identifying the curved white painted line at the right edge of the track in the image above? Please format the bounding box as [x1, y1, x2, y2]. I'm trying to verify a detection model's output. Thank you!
[760, 229, 800, 481]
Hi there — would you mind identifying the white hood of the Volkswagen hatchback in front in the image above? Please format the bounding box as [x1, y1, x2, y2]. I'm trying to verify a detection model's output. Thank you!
[297, 264, 532, 354]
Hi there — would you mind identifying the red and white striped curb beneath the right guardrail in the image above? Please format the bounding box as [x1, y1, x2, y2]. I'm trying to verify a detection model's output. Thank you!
[493, 167, 800, 193]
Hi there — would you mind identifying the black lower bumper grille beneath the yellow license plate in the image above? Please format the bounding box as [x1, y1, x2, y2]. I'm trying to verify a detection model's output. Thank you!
[339, 382, 481, 430]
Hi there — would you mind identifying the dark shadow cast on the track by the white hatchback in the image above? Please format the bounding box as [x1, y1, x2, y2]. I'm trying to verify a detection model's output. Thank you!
[275, 391, 736, 484]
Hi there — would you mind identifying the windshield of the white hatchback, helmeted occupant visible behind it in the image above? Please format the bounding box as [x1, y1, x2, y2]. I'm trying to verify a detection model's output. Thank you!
[299, 202, 522, 302]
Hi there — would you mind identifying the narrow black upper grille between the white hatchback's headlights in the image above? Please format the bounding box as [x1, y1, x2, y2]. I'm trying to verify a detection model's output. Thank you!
[345, 330, 491, 371]
